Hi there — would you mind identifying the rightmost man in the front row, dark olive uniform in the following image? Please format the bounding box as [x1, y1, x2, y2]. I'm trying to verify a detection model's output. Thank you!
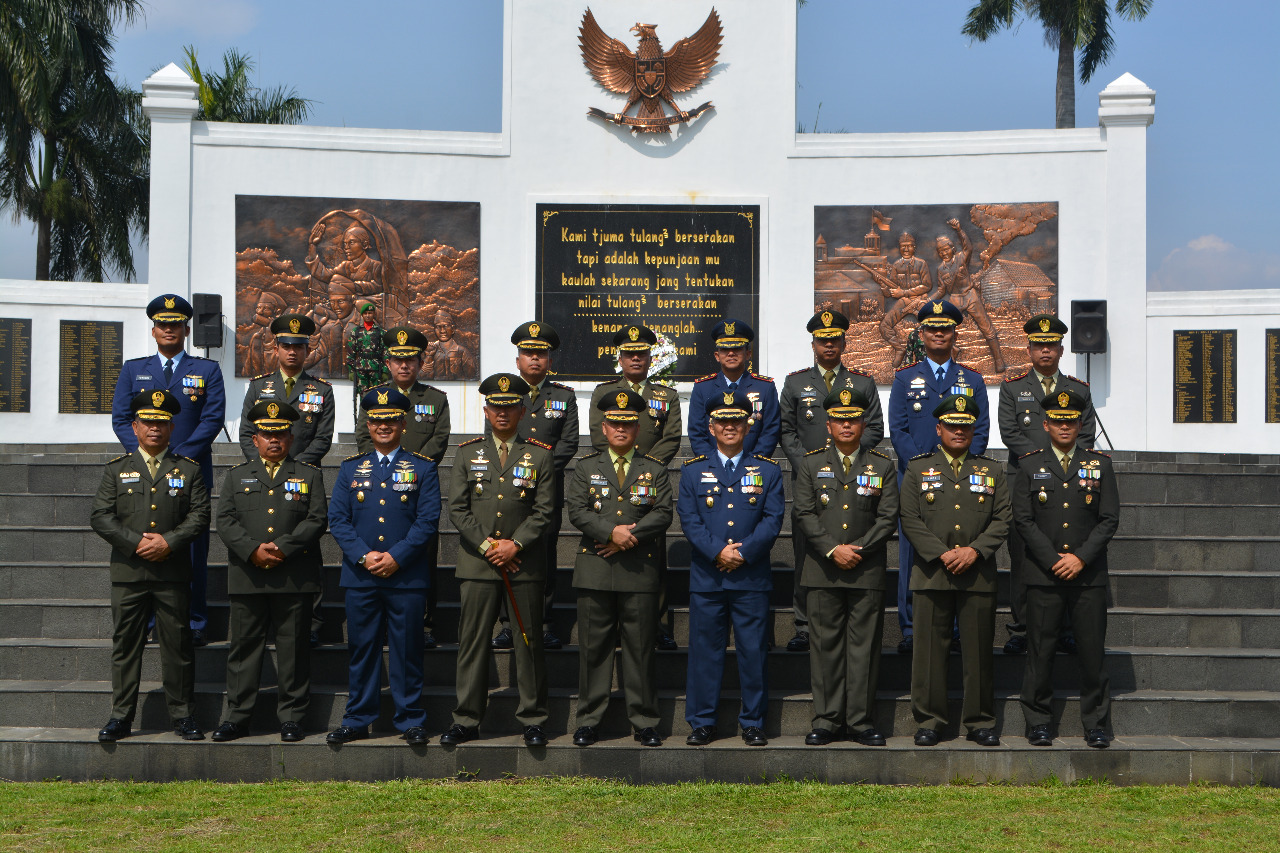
[1012, 388, 1120, 748]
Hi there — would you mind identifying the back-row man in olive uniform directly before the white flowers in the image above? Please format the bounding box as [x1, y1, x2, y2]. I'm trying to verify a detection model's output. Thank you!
[589, 323, 684, 652]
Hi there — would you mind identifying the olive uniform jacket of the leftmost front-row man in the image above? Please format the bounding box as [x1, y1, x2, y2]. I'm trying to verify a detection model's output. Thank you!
[90, 448, 210, 584]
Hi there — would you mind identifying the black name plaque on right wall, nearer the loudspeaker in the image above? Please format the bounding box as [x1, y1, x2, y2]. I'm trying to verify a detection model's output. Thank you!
[1174, 329, 1235, 424]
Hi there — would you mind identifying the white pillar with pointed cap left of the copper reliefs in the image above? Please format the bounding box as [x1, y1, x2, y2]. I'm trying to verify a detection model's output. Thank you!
[142, 63, 200, 298]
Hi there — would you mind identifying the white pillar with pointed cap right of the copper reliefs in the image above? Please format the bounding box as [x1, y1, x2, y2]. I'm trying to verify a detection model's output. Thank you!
[1080, 73, 1171, 450]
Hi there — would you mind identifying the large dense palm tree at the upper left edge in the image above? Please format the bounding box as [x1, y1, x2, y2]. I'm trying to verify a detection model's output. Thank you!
[0, 0, 148, 280]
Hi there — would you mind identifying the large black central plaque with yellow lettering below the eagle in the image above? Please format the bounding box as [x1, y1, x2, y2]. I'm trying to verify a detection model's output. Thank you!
[532, 204, 760, 382]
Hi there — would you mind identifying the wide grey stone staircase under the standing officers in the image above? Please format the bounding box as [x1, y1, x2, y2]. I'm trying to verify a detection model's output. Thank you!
[0, 435, 1280, 784]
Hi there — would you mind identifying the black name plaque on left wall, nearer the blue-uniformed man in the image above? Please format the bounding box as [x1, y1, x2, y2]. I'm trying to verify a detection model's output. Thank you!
[58, 320, 124, 415]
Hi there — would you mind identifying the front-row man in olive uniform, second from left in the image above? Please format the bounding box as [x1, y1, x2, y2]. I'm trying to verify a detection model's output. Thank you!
[214, 402, 329, 743]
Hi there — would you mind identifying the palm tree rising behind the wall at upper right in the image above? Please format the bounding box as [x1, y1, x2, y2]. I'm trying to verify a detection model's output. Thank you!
[961, 0, 1155, 127]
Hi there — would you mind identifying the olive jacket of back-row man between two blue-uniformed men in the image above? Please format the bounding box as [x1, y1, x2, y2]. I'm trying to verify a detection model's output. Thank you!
[780, 365, 884, 461]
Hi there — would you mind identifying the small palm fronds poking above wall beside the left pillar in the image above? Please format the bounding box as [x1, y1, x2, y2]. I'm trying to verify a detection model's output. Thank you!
[182, 45, 311, 124]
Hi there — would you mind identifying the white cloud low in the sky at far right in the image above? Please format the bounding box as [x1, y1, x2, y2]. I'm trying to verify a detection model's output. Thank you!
[1147, 234, 1280, 291]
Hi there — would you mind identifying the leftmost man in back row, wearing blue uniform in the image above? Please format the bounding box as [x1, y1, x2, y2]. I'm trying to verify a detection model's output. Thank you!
[111, 293, 227, 646]
